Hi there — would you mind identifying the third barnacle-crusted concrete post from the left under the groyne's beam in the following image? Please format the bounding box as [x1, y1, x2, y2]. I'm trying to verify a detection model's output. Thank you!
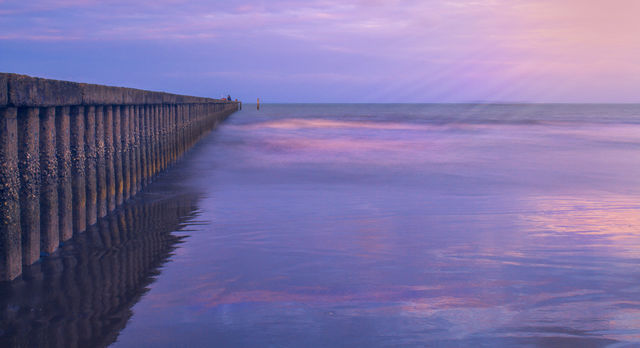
[40, 107, 60, 253]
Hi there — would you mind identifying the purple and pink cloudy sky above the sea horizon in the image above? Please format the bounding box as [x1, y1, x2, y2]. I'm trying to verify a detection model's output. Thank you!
[0, 0, 640, 103]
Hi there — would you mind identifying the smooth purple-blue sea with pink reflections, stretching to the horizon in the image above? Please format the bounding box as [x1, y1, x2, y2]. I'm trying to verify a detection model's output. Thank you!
[0, 104, 640, 347]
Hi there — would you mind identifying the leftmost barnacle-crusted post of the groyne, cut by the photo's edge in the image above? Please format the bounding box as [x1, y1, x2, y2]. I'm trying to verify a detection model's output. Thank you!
[0, 107, 22, 280]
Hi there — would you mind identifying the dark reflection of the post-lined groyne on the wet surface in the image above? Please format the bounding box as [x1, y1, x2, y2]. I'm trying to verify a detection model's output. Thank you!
[0, 195, 196, 347]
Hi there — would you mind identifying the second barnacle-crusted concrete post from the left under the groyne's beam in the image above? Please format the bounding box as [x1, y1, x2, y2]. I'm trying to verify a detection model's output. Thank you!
[18, 108, 40, 265]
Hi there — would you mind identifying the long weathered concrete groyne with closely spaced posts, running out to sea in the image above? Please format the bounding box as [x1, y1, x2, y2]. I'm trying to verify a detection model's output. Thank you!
[0, 73, 240, 281]
